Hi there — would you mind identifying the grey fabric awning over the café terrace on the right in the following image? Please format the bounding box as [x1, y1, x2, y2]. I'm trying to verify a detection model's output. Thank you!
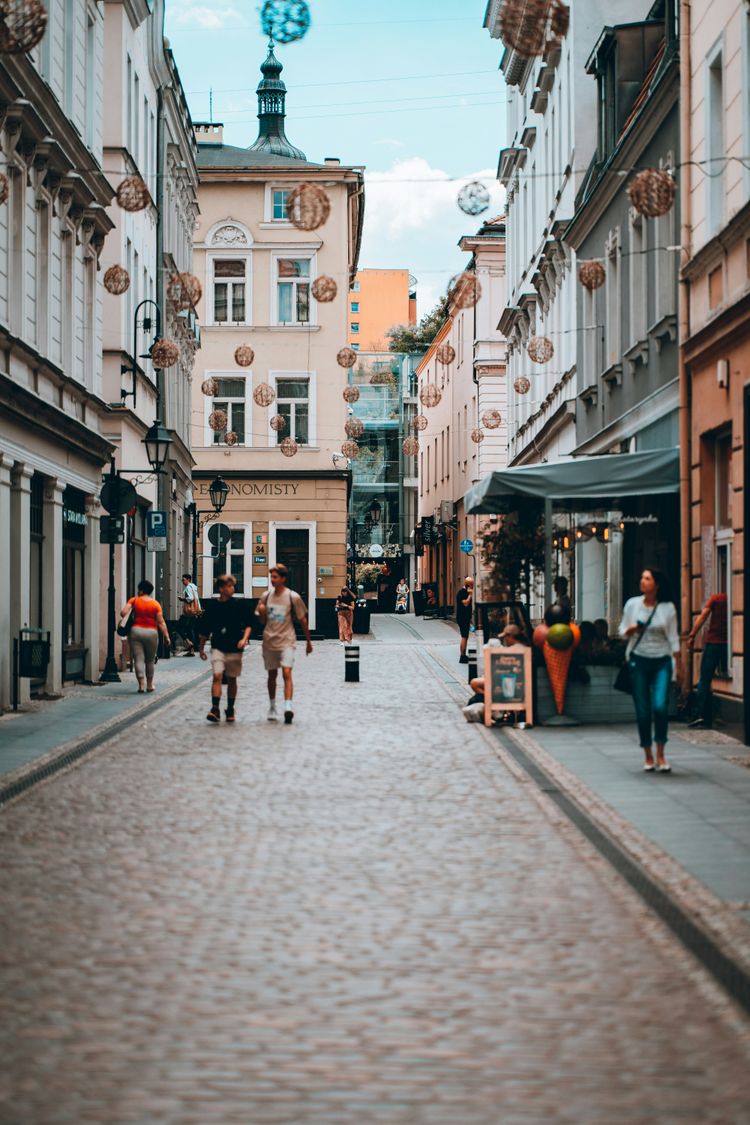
[463, 449, 679, 515]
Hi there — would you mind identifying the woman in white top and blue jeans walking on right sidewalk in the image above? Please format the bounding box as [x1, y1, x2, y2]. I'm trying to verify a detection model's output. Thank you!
[620, 567, 683, 773]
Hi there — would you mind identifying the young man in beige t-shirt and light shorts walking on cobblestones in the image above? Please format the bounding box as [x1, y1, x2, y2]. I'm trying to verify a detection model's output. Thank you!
[256, 563, 313, 723]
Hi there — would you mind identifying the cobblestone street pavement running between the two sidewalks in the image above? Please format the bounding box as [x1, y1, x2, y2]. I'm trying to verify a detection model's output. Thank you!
[0, 637, 750, 1125]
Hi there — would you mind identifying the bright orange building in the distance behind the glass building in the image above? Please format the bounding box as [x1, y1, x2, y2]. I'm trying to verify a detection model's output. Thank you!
[349, 270, 417, 351]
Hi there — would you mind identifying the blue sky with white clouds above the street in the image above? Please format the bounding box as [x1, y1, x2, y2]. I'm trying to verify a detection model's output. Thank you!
[166, 0, 505, 316]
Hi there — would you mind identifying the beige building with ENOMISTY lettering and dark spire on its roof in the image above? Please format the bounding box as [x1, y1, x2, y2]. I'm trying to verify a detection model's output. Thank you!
[191, 51, 364, 635]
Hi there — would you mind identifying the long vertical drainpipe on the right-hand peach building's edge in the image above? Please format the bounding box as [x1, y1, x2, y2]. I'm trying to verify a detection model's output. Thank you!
[678, 0, 693, 675]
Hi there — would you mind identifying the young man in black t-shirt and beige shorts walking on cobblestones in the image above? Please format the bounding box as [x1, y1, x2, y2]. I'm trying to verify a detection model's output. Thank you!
[198, 574, 251, 722]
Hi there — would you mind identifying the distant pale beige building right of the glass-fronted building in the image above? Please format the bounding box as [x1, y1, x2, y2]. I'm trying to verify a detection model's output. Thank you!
[416, 217, 508, 605]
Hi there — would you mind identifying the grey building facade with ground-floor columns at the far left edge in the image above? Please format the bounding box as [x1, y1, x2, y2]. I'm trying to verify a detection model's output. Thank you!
[0, 0, 112, 708]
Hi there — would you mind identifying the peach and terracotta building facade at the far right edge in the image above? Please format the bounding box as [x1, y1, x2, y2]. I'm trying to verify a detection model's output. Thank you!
[679, 0, 750, 743]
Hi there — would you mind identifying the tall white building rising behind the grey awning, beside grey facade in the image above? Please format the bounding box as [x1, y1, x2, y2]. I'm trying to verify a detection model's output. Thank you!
[485, 0, 632, 465]
